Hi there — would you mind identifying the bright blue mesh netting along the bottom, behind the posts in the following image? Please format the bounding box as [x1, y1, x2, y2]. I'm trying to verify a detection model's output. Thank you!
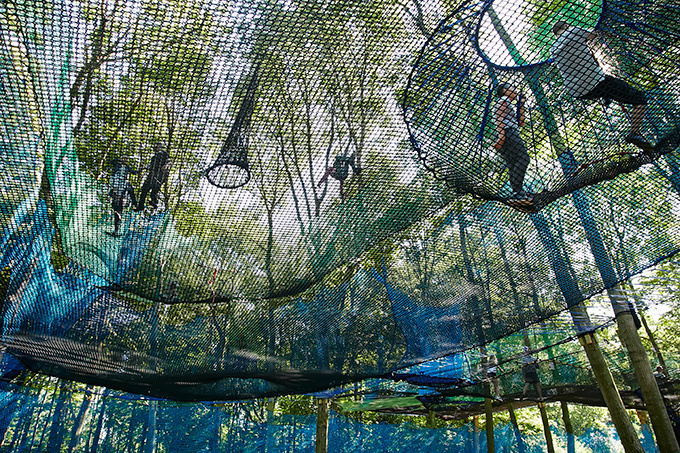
[0, 381, 657, 453]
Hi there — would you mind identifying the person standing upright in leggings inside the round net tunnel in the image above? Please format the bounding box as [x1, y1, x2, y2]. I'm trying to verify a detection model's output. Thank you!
[493, 83, 532, 202]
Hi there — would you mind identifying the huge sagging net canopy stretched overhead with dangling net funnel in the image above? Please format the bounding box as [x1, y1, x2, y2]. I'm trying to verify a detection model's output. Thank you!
[0, 0, 680, 400]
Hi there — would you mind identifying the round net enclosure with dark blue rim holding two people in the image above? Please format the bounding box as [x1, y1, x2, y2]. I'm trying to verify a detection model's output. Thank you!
[404, 0, 680, 212]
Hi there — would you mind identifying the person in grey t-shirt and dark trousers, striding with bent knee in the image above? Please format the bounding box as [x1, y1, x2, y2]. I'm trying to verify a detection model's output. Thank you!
[550, 20, 653, 152]
